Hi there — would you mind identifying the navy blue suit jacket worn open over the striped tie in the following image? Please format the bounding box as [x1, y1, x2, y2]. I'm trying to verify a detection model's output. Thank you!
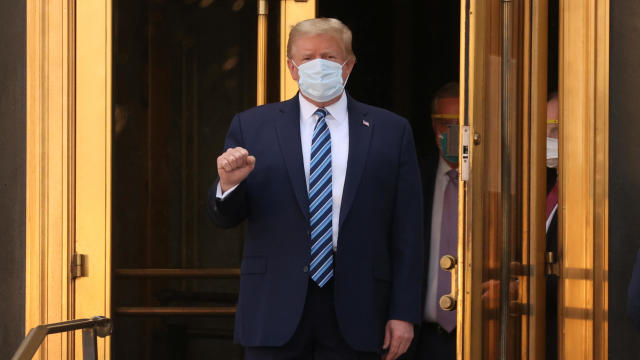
[208, 96, 423, 351]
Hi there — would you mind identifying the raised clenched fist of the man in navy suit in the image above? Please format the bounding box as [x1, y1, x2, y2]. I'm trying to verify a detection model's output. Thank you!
[218, 147, 256, 193]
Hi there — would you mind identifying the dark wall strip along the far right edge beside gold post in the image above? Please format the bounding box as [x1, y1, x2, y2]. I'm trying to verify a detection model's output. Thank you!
[609, 0, 640, 360]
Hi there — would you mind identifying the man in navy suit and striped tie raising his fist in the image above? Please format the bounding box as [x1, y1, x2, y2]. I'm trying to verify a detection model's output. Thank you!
[208, 19, 423, 359]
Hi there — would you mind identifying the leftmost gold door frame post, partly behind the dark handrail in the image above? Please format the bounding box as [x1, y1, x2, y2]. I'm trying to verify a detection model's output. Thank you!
[25, 0, 73, 359]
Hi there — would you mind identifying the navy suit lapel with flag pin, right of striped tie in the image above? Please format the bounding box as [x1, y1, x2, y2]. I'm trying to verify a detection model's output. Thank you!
[339, 96, 374, 228]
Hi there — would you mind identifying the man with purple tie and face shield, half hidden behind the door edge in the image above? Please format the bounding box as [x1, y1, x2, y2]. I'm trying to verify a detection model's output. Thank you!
[416, 82, 459, 360]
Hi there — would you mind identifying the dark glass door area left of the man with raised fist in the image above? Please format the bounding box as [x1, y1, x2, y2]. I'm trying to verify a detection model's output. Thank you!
[112, 0, 279, 359]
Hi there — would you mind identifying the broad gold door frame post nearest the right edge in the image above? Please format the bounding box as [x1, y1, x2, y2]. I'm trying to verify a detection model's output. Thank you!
[558, 0, 610, 360]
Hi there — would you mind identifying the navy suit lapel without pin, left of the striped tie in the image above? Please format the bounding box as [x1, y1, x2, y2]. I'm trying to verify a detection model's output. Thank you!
[276, 95, 309, 219]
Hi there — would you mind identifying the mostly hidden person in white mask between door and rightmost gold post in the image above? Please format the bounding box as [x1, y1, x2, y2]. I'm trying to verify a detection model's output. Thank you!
[545, 93, 559, 360]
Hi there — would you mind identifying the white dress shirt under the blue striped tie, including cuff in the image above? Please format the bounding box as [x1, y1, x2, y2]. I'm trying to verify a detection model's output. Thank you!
[216, 92, 349, 250]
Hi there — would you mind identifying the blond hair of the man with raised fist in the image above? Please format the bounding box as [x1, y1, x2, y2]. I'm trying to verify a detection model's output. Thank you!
[287, 18, 356, 59]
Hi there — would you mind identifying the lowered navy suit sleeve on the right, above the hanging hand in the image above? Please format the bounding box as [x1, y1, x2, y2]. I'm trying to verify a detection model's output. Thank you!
[389, 122, 424, 324]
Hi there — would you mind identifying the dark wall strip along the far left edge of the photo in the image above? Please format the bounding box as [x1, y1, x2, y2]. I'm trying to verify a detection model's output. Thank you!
[0, 1, 27, 359]
